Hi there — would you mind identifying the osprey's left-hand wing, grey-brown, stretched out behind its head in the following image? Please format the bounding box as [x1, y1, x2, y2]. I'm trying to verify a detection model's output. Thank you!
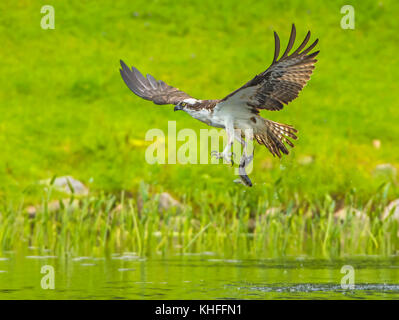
[120, 60, 192, 104]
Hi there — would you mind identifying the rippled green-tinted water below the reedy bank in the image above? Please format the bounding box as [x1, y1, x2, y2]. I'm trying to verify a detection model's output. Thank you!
[0, 252, 399, 299]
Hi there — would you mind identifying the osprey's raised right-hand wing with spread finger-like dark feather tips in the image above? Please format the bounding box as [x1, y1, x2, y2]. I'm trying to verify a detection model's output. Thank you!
[221, 24, 319, 112]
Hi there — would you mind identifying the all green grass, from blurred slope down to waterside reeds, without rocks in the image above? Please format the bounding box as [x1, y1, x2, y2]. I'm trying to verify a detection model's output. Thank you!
[0, 0, 399, 254]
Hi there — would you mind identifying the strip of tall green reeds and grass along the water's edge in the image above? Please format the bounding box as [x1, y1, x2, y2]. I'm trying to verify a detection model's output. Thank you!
[0, 185, 399, 258]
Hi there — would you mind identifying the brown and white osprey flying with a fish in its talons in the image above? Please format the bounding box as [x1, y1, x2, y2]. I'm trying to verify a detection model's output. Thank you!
[120, 24, 319, 186]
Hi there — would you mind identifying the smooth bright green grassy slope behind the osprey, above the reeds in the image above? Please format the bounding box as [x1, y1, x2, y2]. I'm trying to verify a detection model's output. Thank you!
[0, 1, 399, 202]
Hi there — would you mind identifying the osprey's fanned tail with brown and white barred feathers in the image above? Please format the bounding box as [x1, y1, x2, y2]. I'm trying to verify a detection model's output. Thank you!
[254, 118, 298, 158]
